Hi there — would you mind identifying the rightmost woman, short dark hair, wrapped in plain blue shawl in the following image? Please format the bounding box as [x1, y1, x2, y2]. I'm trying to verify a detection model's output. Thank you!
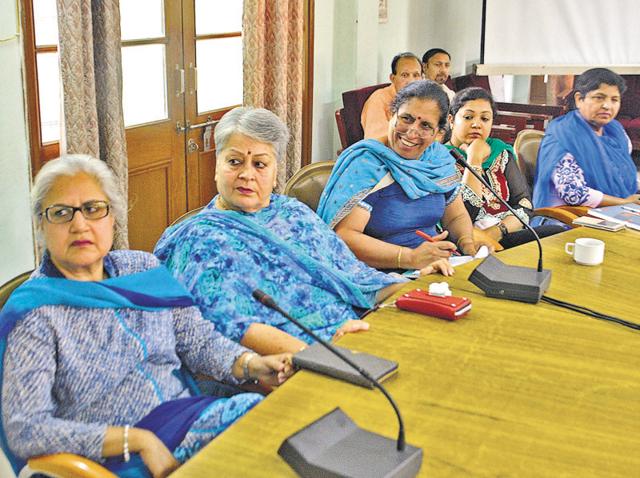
[533, 68, 640, 208]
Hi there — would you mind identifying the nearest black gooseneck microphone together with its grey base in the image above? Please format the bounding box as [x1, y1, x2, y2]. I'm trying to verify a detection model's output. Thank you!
[252, 289, 422, 477]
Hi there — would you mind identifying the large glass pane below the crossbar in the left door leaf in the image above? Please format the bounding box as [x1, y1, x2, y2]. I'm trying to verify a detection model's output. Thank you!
[122, 45, 167, 126]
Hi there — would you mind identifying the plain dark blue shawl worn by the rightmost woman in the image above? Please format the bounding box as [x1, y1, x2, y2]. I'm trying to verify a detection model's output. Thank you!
[533, 110, 637, 208]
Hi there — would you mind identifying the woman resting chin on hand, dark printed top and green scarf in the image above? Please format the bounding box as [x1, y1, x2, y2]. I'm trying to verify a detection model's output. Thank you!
[447, 87, 564, 249]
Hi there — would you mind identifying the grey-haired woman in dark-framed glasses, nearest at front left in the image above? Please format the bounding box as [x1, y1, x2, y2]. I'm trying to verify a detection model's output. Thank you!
[0, 155, 291, 477]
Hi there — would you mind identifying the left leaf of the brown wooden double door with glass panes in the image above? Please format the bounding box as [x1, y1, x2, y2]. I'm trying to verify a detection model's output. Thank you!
[120, 0, 187, 251]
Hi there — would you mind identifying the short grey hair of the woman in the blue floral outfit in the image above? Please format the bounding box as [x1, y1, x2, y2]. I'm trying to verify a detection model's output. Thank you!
[214, 106, 289, 162]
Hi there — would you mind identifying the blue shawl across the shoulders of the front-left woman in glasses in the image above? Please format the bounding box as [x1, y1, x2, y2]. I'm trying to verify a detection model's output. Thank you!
[0, 266, 194, 474]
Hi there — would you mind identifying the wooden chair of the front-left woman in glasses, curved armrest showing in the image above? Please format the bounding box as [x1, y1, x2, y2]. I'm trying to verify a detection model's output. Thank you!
[0, 271, 116, 478]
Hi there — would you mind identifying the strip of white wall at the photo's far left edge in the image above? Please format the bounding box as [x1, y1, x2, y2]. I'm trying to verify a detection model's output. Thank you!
[0, 0, 34, 284]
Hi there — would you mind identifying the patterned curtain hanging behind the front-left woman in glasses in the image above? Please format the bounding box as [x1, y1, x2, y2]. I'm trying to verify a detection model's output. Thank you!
[57, 0, 128, 249]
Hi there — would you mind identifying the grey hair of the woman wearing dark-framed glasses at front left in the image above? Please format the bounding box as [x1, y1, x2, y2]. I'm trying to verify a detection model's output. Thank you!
[31, 154, 127, 244]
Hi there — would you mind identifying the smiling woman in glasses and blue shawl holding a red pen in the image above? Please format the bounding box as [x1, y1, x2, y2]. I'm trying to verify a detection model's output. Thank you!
[318, 80, 488, 275]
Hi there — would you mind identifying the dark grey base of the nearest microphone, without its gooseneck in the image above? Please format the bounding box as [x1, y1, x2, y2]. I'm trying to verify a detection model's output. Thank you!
[278, 408, 422, 478]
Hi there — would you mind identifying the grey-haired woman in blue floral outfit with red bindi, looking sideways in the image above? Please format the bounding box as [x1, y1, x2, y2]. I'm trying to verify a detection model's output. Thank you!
[154, 108, 403, 353]
